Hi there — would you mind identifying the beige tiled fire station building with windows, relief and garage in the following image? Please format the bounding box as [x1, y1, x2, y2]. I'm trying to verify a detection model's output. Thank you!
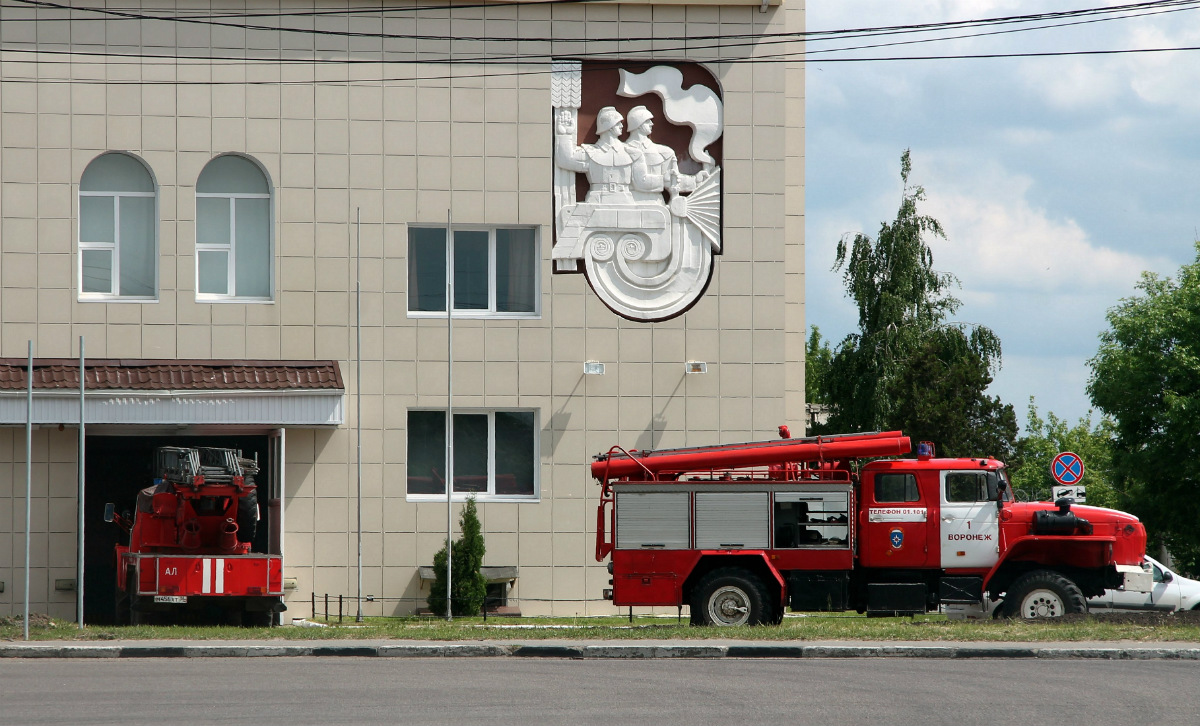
[0, 0, 804, 623]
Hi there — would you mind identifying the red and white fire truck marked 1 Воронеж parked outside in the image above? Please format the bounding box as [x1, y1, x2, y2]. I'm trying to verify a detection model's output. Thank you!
[592, 426, 1152, 625]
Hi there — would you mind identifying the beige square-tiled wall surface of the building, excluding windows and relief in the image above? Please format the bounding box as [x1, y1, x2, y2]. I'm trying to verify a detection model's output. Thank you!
[0, 2, 804, 617]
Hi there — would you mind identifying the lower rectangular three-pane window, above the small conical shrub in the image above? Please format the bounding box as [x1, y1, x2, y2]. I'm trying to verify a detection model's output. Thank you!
[408, 409, 539, 500]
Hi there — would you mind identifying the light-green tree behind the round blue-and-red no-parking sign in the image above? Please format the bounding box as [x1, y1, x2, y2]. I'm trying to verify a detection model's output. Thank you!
[1009, 397, 1122, 508]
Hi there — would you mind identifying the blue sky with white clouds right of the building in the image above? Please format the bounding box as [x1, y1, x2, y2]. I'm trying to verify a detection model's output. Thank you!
[805, 0, 1200, 432]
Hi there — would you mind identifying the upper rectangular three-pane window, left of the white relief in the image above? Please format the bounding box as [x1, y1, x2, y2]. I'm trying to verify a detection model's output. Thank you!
[408, 227, 539, 318]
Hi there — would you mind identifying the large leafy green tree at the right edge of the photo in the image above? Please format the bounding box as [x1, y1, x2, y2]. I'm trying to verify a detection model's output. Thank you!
[1087, 241, 1200, 572]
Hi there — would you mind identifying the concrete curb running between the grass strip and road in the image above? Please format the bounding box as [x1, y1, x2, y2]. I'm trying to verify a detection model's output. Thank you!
[0, 642, 1200, 660]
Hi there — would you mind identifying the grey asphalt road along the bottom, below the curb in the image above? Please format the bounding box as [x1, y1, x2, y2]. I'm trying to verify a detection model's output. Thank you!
[0, 658, 1200, 726]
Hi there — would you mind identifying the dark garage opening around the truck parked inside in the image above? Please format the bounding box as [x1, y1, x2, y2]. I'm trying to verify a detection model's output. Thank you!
[83, 433, 282, 625]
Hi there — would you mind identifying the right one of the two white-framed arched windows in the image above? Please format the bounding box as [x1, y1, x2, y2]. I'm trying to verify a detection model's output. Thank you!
[196, 155, 274, 300]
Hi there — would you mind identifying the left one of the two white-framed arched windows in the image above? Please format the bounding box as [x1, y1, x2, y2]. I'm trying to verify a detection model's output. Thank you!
[78, 152, 158, 300]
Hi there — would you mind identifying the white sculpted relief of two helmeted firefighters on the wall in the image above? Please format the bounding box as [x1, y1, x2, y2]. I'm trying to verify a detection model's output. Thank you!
[552, 62, 721, 320]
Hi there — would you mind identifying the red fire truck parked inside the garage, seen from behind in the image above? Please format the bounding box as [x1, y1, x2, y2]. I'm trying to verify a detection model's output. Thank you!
[104, 446, 286, 625]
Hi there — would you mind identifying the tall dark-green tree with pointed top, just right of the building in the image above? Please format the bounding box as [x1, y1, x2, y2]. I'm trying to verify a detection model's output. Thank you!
[822, 150, 1016, 456]
